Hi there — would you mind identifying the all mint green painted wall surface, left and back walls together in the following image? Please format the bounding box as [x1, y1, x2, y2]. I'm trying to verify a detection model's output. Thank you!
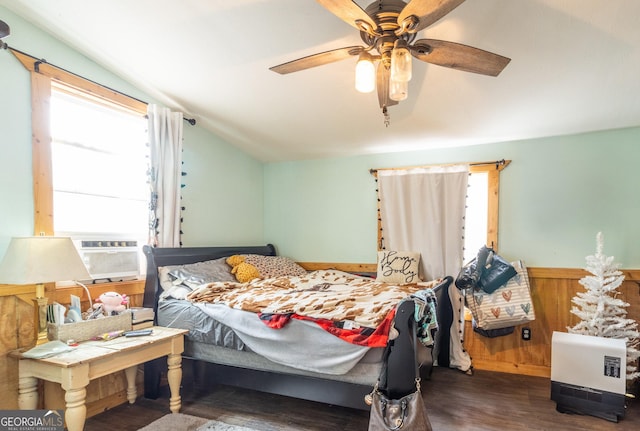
[0, 7, 640, 268]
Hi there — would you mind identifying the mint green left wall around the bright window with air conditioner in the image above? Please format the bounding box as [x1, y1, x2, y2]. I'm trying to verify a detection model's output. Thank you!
[0, 7, 264, 257]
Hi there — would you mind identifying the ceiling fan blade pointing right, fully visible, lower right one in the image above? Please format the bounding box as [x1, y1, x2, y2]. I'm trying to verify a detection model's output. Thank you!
[409, 39, 511, 76]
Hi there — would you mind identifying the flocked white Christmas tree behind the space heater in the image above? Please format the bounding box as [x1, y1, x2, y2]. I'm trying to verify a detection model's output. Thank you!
[567, 232, 640, 380]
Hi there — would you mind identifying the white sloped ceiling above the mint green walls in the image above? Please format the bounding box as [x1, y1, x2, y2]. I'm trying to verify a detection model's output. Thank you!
[0, 0, 640, 161]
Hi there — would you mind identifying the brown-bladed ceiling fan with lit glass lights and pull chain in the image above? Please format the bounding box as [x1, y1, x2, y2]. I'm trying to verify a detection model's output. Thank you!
[270, 0, 511, 125]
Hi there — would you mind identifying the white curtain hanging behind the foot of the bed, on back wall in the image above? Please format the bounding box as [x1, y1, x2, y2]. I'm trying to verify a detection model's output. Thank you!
[378, 165, 471, 371]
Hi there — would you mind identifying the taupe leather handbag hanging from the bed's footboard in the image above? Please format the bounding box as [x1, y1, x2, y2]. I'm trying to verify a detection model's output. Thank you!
[365, 310, 432, 431]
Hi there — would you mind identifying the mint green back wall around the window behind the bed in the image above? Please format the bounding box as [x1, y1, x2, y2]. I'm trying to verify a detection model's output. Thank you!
[265, 126, 640, 268]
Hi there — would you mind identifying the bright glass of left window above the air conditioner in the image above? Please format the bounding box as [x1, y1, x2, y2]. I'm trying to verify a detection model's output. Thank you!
[50, 84, 149, 243]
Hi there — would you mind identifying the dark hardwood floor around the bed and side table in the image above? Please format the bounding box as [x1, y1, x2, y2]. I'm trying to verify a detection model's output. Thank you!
[85, 364, 640, 431]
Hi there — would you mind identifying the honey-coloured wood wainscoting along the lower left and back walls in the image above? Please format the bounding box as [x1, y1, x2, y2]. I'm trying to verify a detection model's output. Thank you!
[0, 268, 640, 417]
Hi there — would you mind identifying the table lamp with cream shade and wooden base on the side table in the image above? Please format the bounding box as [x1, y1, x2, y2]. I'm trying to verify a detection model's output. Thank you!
[0, 236, 91, 344]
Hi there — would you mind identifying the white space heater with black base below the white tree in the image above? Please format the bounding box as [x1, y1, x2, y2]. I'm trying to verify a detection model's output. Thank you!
[551, 332, 627, 422]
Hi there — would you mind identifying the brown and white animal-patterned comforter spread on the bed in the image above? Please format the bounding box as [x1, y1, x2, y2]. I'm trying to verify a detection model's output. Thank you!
[187, 270, 442, 329]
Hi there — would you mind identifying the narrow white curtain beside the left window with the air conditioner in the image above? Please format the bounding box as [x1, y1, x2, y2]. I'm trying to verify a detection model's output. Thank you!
[147, 104, 183, 247]
